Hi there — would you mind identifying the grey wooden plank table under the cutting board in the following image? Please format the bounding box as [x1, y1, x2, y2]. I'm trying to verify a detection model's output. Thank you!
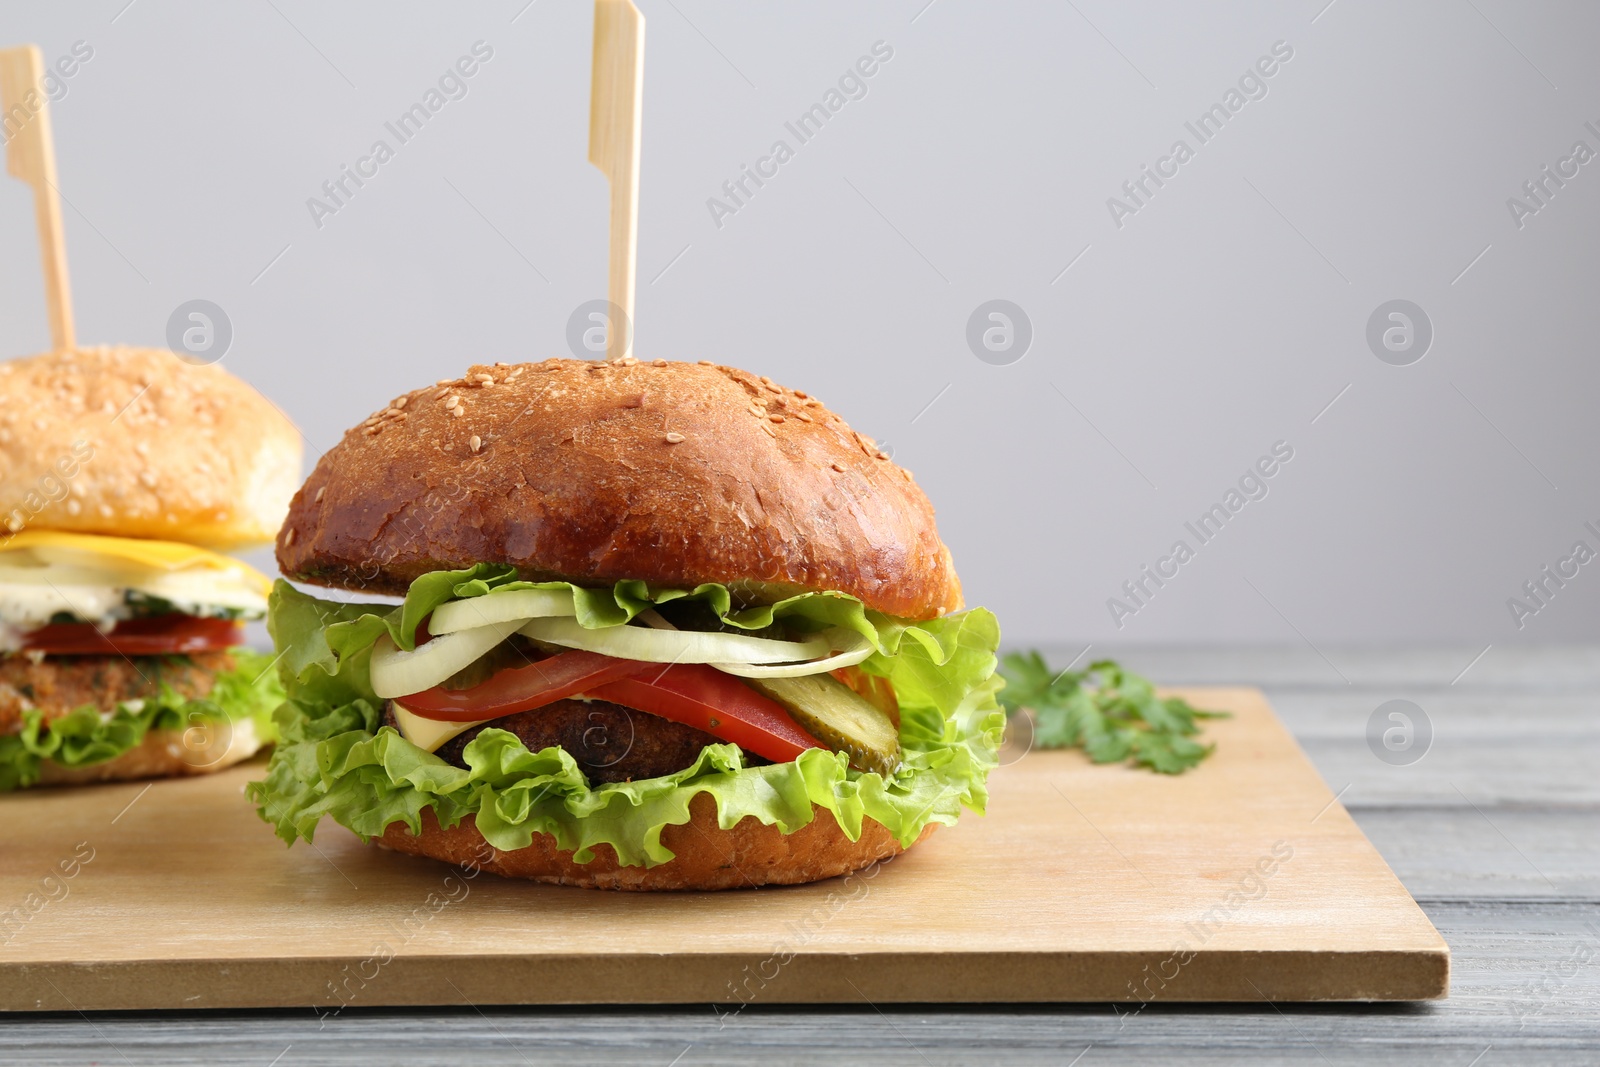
[0, 646, 1600, 1067]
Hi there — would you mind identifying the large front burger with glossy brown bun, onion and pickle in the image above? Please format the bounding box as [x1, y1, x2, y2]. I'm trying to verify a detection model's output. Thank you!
[246, 358, 1003, 889]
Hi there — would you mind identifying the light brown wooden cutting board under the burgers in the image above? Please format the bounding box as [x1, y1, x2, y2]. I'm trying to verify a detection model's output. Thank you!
[0, 689, 1450, 1014]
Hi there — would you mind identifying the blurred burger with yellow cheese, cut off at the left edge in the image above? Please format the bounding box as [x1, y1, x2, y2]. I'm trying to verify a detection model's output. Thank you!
[0, 347, 301, 790]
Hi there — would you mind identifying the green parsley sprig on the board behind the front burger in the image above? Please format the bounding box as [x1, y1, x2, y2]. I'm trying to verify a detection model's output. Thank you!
[1000, 653, 1229, 774]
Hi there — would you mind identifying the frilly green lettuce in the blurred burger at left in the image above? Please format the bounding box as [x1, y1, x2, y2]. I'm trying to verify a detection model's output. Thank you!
[0, 648, 283, 792]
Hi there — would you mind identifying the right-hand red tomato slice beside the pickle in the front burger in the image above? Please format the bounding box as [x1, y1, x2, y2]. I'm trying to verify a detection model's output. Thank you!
[587, 664, 826, 763]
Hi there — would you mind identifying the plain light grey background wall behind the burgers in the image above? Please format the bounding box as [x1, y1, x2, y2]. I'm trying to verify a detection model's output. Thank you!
[0, 0, 1600, 655]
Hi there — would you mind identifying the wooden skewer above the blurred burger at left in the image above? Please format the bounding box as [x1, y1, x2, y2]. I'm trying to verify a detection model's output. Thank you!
[0, 45, 77, 352]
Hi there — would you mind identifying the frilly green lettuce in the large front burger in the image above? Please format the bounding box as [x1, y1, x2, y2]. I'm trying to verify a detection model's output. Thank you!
[246, 575, 1005, 867]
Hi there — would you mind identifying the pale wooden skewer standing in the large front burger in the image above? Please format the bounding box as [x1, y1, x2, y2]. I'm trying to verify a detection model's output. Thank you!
[589, 0, 645, 360]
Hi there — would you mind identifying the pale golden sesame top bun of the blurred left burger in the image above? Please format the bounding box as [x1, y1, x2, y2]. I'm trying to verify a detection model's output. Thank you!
[0, 347, 301, 547]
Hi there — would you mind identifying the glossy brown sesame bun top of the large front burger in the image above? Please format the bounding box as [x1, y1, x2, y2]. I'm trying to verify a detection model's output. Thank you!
[278, 358, 962, 619]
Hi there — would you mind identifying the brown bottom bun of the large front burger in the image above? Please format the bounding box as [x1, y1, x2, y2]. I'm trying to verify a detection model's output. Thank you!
[376, 793, 936, 891]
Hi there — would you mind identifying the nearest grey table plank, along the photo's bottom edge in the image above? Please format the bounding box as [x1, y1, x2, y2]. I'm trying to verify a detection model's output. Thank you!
[6, 902, 1600, 1067]
